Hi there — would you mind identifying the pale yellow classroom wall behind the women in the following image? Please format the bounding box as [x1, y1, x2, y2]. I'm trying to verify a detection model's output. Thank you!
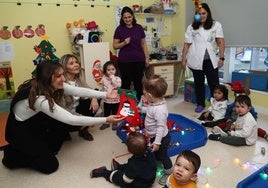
[0, 0, 185, 88]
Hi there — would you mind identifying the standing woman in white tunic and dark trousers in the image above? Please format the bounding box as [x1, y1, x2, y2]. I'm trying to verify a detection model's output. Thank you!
[182, 3, 225, 113]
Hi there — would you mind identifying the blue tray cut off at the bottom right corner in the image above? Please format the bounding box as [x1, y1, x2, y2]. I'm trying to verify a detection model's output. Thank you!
[237, 164, 268, 188]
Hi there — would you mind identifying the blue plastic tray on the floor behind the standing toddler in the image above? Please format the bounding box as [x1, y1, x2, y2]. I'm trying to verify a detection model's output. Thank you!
[116, 113, 207, 157]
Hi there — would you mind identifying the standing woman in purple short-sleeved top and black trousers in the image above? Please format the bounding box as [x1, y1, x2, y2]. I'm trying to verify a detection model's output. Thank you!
[113, 7, 149, 100]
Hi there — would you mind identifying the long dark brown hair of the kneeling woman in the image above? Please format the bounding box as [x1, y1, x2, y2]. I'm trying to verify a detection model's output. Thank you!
[22, 60, 63, 112]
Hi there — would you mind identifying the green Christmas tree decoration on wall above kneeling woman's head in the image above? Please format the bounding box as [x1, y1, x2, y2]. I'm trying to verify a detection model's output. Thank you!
[32, 40, 59, 76]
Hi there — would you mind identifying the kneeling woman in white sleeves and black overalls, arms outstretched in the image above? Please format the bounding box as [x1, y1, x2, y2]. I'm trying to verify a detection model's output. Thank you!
[2, 61, 122, 174]
